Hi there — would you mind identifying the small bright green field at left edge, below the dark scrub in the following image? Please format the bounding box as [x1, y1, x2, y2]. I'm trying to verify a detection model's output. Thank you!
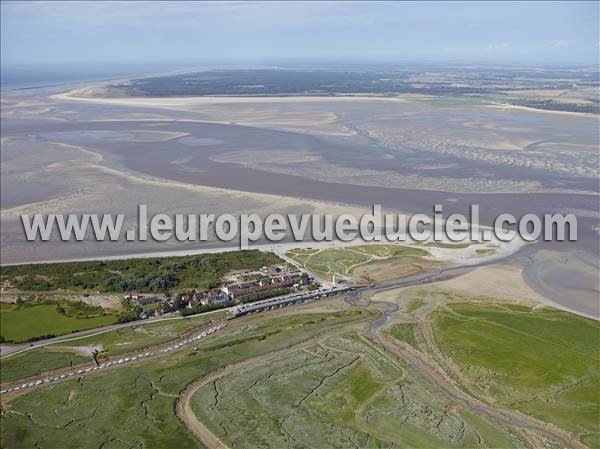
[0, 303, 117, 343]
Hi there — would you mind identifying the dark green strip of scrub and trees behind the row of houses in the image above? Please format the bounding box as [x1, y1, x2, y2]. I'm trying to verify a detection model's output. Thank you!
[0, 250, 282, 292]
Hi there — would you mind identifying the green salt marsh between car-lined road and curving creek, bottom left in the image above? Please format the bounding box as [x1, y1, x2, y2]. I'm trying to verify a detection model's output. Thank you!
[0, 310, 374, 449]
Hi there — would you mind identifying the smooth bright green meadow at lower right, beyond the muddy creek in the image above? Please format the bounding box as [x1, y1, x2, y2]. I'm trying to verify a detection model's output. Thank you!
[433, 304, 600, 447]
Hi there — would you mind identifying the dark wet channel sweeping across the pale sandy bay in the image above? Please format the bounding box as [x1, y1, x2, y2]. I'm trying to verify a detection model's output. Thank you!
[7, 117, 600, 254]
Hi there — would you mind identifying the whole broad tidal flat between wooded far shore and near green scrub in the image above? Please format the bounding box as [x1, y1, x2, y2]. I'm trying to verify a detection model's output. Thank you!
[2, 88, 600, 318]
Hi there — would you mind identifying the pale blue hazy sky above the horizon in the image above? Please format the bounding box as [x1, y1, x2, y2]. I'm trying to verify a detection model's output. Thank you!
[1, 1, 600, 67]
